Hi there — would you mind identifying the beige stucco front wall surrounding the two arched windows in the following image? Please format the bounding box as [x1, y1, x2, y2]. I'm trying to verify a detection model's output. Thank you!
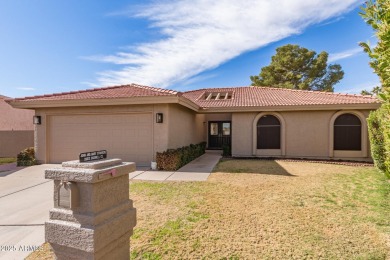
[232, 110, 371, 160]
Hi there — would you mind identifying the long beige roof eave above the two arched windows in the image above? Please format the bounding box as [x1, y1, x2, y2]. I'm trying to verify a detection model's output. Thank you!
[199, 103, 381, 113]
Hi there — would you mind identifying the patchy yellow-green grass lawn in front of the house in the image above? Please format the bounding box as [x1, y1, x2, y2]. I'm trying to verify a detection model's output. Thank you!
[30, 160, 390, 259]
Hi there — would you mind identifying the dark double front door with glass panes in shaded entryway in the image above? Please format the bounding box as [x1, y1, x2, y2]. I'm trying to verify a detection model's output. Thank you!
[208, 121, 232, 149]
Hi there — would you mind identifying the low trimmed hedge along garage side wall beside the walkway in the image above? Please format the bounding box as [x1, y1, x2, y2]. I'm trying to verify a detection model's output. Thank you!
[156, 142, 206, 171]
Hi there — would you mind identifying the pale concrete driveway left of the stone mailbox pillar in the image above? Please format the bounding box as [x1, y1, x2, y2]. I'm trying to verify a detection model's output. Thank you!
[0, 164, 58, 259]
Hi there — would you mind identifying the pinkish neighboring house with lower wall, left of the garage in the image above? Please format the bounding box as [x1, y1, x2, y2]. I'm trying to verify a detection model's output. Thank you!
[0, 95, 34, 157]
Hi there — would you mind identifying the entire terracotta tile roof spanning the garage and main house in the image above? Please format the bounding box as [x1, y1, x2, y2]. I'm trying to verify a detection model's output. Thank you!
[12, 84, 380, 108]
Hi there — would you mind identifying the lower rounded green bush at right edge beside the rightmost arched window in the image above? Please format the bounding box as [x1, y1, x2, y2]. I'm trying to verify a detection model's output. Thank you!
[368, 104, 390, 178]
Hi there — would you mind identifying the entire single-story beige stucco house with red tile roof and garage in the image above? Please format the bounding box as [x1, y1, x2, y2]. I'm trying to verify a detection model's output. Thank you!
[8, 84, 380, 165]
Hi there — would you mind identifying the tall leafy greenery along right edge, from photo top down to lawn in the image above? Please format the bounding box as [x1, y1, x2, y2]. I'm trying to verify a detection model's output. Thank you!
[360, 0, 390, 178]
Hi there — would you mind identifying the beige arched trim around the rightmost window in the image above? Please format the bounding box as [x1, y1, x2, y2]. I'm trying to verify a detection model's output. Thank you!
[329, 110, 368, 158]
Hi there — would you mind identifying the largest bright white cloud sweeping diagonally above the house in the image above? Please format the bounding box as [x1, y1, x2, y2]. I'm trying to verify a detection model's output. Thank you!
[89, 0, 361, 87]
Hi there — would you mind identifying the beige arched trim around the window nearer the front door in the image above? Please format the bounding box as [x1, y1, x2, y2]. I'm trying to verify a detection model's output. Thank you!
[252, 112, 286, 156]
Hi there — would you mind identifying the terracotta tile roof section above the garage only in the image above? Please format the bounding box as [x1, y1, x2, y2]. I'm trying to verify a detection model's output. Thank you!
[14, 84, 178, 102]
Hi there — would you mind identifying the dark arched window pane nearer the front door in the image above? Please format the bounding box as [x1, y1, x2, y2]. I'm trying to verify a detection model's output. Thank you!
[257, 115, 280, 149]
